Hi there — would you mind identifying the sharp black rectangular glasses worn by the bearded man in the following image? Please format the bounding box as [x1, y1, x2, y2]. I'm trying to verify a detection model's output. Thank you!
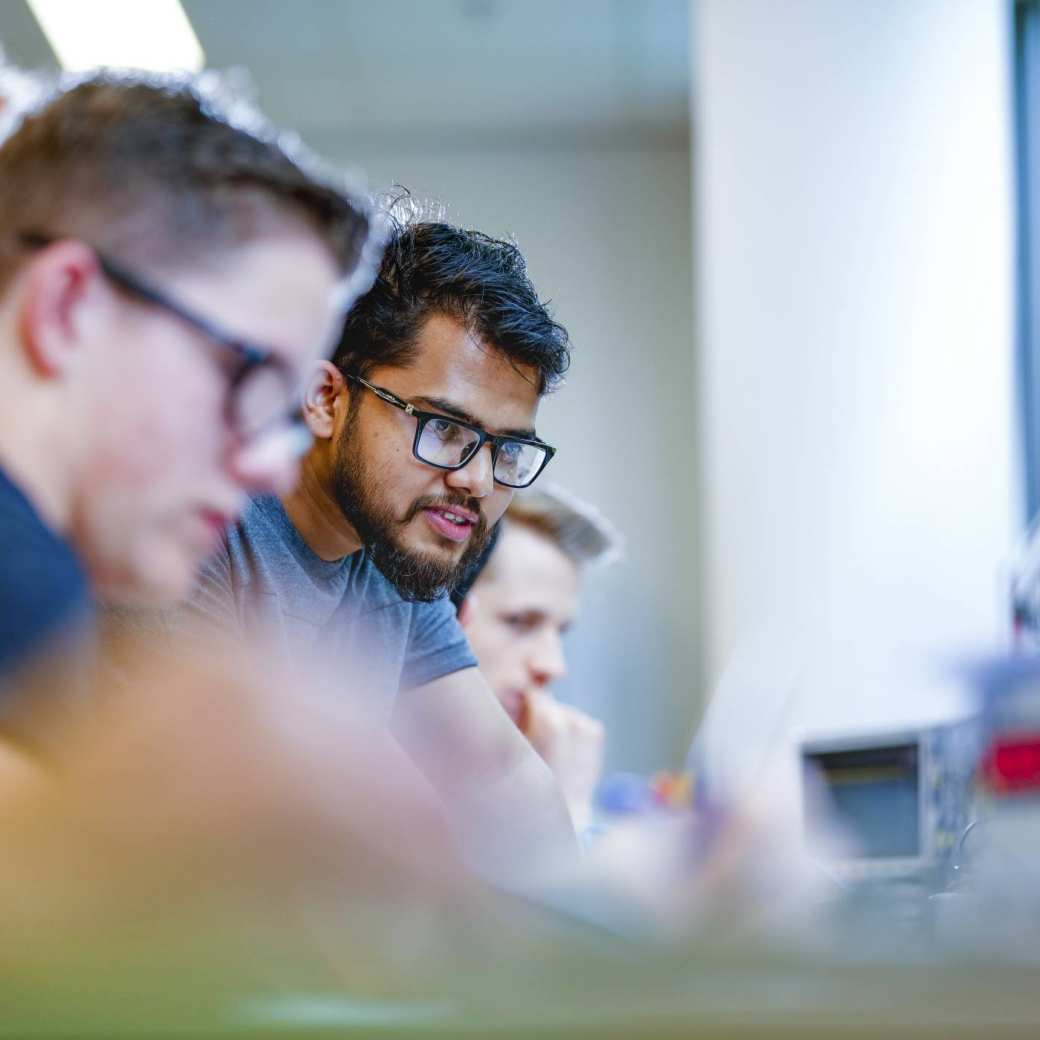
[346, 372, 556, 488]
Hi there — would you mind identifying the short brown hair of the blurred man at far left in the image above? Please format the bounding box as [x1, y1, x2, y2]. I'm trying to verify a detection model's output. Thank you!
[0, 73, 378, 289]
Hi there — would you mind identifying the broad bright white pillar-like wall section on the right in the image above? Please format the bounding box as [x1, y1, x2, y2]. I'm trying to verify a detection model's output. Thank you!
[693, 0, 1017, 794]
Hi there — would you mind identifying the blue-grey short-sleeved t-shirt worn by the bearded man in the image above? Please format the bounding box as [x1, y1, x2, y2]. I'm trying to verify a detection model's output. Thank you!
[190, 496, 476, 714]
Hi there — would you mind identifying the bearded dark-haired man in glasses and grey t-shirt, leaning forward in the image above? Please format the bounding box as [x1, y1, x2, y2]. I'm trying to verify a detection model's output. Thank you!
[191, 222, 574, 879]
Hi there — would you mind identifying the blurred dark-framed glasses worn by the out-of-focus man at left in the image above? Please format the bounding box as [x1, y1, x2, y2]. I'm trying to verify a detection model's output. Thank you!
[19, 231, 303, 441]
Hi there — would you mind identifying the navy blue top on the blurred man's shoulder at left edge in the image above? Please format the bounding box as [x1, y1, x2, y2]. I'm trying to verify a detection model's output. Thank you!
[0, 469, 89, 682]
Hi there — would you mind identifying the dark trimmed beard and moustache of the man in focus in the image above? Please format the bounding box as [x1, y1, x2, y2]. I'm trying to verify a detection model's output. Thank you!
[332, 413, 488, 603]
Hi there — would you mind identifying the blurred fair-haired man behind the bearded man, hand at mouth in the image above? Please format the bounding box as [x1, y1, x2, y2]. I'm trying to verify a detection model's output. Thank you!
[460, 487, 619, 827]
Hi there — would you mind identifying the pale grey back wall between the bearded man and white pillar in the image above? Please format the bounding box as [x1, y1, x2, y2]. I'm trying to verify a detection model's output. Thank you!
[314, 135, 701, 769]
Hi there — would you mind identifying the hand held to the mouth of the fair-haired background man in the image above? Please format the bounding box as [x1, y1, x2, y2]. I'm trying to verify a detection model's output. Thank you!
[520, 691, 604, 827]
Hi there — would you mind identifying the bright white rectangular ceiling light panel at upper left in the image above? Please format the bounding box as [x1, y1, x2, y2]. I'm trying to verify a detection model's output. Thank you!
[27, 0, 206, 72]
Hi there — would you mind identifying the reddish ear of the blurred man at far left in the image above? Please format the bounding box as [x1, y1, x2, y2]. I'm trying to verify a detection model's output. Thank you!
[18, 239, 100, 378]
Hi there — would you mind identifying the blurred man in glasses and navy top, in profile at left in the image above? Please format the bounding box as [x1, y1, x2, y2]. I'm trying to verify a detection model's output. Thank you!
[0, 76, 372, 715]
